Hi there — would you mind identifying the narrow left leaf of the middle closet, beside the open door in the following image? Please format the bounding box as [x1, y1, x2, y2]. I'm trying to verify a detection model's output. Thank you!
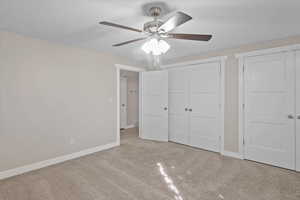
[169, 68, 189, 144]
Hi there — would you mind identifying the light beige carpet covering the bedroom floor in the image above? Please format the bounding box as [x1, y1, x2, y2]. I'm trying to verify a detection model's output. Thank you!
[0, 129, 300, 200]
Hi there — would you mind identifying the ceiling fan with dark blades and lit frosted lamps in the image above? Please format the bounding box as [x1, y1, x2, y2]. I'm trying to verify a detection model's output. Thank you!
[99, 7, 212, 55]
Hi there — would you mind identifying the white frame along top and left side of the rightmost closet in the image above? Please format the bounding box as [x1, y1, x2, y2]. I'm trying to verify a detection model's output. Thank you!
[235, 44, 300, 159]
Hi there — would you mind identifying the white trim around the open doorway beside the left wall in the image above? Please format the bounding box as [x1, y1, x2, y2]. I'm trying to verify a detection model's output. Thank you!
[115, 64, 146, 145]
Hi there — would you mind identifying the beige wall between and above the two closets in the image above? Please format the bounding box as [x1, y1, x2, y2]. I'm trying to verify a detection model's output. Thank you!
[166, 36, 300, 152]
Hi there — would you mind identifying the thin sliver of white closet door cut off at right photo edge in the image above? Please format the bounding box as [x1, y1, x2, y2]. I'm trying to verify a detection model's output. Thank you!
[296, 51, 300, 171]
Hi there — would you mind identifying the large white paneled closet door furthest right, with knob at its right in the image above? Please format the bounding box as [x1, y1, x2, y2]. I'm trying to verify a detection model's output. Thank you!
[244, 53, 295, 169]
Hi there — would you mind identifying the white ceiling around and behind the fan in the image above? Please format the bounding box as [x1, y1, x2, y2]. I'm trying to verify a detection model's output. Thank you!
[0, 0, 300, 65]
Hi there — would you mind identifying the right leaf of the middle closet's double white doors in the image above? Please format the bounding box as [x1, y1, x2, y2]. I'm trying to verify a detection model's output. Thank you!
[188, 63, 221, 152]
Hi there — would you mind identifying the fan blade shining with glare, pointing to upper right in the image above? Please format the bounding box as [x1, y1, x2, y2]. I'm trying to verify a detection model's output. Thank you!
[158, 12, 192, 32]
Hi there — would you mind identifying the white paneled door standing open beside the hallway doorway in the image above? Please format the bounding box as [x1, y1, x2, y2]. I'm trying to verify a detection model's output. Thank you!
[140, 71, 169, 141]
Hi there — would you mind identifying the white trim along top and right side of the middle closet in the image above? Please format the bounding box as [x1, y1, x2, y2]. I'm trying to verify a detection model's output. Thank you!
[161, 56, 225, 155]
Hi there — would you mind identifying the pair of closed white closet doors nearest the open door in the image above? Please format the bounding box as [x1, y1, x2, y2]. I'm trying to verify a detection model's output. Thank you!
[169, 62, 221, 152]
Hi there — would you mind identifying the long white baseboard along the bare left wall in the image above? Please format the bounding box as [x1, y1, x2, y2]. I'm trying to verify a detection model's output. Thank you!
[0, 142, 120, 180]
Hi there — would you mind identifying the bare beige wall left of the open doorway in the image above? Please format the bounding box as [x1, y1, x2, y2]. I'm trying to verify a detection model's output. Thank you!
[0, 32, 134, 171]
